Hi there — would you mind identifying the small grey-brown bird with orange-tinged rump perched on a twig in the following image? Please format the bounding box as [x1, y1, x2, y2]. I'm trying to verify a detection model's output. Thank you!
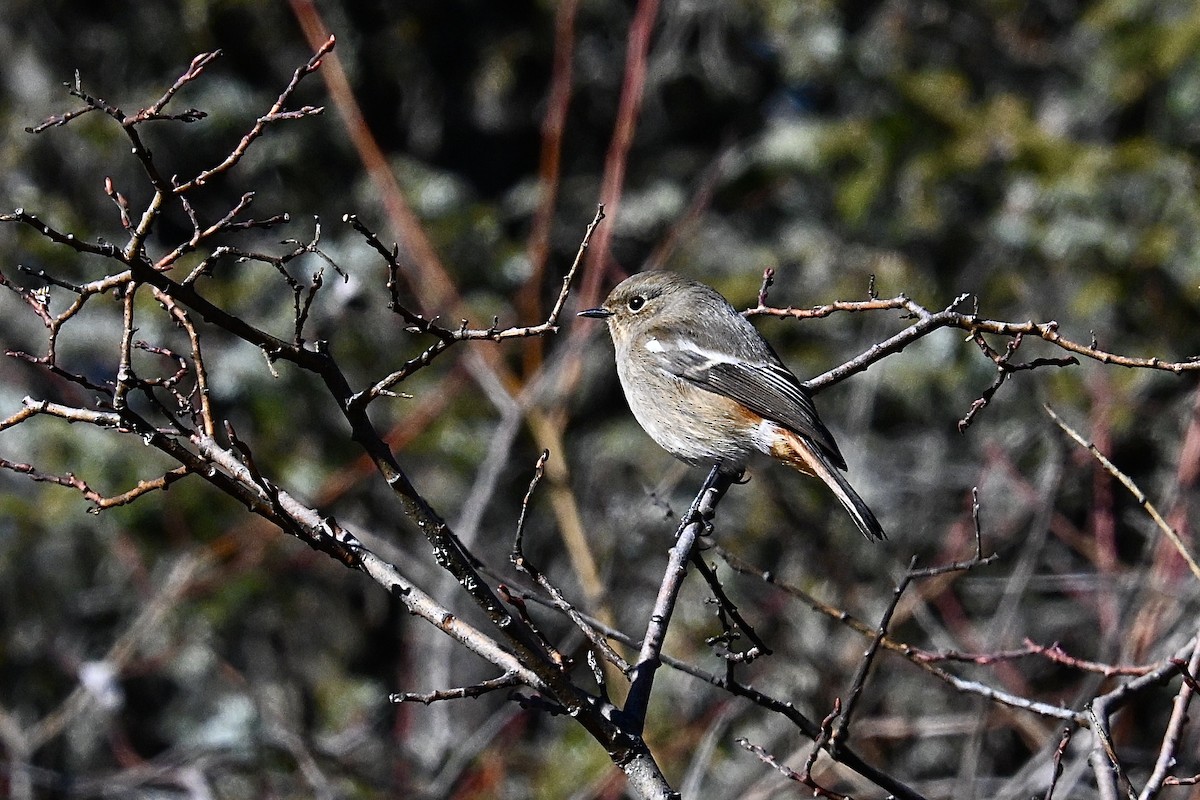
[578, 270, 887, 540]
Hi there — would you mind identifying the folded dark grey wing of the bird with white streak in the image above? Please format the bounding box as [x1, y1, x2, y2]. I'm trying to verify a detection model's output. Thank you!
[644, 337, 846, 469]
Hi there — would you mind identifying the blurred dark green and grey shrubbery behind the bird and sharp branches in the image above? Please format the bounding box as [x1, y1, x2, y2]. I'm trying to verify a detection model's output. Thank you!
[0, 0, 1200, 799]
